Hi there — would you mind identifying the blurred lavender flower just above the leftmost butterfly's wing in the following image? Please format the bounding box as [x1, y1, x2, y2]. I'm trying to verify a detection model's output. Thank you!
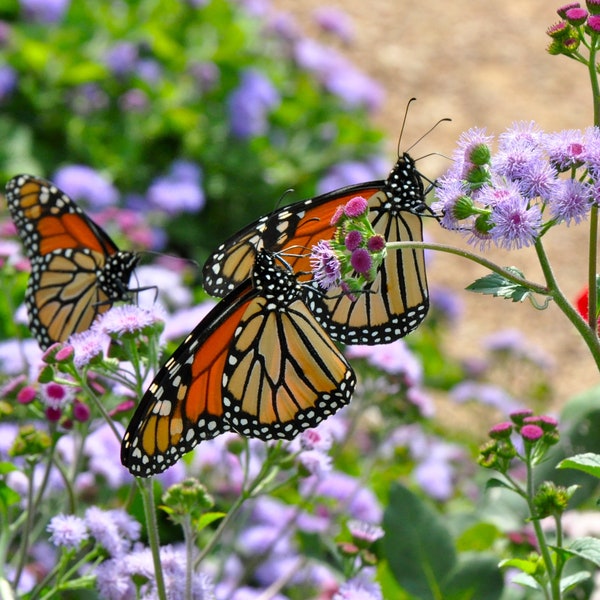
[53, 165, 119, 208]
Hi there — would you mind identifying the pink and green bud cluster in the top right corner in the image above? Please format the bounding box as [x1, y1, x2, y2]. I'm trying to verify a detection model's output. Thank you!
[547, 0, 600, 58]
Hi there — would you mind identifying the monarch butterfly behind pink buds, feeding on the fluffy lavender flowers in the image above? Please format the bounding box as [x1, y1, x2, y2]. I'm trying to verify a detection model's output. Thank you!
[203, 153, 430, 344]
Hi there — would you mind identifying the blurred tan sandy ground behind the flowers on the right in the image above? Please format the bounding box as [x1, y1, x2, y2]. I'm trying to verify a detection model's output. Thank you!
[273, 0, 599, 404]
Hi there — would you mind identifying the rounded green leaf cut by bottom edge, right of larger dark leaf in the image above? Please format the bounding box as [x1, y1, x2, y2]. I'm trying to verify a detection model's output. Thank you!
[442, 553, 504, 600]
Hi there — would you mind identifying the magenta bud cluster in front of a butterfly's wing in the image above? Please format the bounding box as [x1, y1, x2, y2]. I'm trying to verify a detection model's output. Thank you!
[310, 196, 386, 299]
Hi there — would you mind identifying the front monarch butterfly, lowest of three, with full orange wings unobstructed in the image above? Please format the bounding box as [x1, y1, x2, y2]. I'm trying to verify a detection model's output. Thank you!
[121, 250, 356, 477]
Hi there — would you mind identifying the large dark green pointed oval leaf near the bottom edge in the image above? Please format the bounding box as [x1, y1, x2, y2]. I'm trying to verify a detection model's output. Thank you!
[383, 484, 457, 600]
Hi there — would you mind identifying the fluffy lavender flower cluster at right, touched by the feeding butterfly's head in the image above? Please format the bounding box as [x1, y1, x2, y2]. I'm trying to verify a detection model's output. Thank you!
[433, 122, 600, 249]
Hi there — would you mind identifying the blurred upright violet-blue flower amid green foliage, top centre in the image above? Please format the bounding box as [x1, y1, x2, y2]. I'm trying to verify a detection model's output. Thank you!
[227, 69, 281, 139]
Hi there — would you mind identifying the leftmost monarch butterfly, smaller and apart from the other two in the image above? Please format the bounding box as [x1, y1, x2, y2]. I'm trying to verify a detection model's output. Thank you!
[6, 175, 139, 350]
